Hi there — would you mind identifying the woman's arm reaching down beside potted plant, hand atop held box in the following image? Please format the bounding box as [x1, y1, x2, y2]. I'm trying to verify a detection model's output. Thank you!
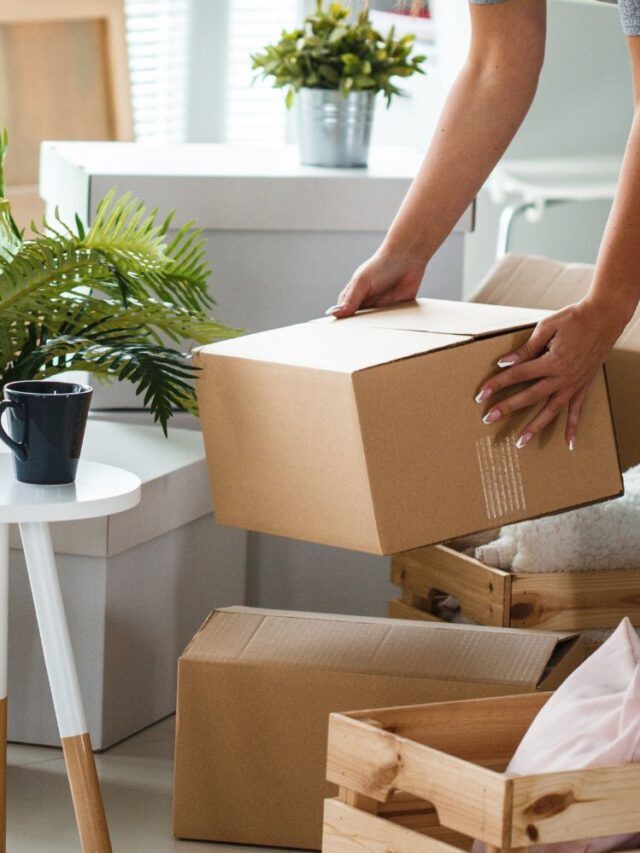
[327, 0, 546, 317]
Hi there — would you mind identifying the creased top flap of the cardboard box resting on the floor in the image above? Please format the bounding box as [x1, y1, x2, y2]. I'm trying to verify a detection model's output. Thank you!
[183, 608, 567, 689]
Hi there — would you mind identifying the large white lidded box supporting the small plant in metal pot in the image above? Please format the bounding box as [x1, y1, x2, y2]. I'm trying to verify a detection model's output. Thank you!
[41, 142, 473, 615]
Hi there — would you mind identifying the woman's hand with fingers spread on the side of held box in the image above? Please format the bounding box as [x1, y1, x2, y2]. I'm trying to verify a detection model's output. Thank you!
[475, 296, 630, 450]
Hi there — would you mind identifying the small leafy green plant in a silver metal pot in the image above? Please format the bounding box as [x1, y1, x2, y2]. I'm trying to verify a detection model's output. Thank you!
[251, 0, 425, 167]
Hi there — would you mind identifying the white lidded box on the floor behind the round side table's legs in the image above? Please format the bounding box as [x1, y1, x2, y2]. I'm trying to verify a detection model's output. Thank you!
[3, 420, 246, 749]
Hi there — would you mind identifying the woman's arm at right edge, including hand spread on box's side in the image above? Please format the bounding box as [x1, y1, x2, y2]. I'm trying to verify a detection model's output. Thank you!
[476, 36, 640, 450]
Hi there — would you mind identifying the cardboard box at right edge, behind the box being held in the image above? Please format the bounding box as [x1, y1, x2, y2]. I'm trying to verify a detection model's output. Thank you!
[472, 255, 640, 471]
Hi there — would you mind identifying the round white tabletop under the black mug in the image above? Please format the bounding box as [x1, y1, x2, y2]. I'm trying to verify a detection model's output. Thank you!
[0, 453, 140, 523]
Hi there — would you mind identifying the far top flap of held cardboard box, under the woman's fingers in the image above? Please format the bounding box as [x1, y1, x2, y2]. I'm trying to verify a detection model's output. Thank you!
[318, 299, 549, 338]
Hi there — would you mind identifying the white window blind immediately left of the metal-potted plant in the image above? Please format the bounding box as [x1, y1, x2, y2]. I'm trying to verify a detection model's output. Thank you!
[225, 0, 303, 144]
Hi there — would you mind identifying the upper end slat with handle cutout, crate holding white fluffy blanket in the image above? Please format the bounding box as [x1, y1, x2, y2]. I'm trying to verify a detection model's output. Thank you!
[391, 545, 511, 626]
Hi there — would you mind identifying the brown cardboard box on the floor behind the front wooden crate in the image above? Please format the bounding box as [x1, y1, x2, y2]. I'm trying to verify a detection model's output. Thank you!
[173, 607, 585, 849]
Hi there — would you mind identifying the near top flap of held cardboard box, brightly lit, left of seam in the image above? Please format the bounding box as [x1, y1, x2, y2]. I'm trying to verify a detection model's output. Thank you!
[198, 321, 469, 373]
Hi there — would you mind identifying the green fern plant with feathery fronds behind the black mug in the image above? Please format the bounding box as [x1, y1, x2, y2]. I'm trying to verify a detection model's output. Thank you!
[0, 132, 237, 433]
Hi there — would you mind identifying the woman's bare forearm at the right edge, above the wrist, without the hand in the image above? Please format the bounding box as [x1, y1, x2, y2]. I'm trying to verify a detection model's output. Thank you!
[588, 106, 640, 331]
